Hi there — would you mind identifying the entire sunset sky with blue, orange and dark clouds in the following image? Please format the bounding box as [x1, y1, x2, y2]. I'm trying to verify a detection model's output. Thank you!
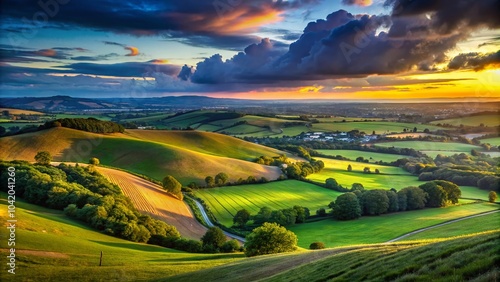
[0, 0, 500, 101]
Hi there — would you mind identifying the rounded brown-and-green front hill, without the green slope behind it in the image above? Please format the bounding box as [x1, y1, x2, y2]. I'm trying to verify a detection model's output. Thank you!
[0, 128, 281, 185]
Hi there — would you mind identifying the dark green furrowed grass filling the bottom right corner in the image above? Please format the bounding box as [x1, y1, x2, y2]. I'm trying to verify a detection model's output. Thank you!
[263, 232, 500, 281]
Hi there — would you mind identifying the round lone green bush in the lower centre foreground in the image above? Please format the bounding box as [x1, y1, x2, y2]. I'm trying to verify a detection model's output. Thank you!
[245, 222, 297, 257]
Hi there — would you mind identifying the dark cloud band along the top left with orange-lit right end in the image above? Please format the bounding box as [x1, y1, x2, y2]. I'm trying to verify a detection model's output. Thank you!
[1, 0, 317, 48]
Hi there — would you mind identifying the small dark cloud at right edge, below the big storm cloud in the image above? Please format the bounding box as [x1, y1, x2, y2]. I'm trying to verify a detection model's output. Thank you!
[448, 51, 500, 71]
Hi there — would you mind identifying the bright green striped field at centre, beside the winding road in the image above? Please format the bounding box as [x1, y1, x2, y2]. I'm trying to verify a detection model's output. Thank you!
[196, 180, 341, 226]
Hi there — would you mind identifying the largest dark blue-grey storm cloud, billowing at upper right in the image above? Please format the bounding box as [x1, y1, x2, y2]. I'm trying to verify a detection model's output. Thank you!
[191, 0, 500, 84]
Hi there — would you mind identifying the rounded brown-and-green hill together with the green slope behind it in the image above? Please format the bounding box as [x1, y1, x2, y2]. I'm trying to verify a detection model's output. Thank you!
[0, 128, 282, 185]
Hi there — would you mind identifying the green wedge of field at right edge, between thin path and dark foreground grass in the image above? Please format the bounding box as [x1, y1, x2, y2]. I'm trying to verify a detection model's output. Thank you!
[404, 212, 500, 241]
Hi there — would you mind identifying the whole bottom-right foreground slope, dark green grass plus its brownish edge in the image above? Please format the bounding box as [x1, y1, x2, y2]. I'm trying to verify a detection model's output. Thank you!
[168, 232, 500, 282]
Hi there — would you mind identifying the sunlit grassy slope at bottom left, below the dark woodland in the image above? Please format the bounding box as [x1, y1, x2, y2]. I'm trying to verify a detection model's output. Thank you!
[0, 195, 243, 281]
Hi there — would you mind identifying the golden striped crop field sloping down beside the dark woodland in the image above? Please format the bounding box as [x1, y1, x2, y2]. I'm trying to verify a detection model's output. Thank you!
[97, 167, 207, 239]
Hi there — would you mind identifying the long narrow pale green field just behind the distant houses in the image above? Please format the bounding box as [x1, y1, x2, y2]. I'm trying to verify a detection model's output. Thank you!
[311, 121, 443, 134]
